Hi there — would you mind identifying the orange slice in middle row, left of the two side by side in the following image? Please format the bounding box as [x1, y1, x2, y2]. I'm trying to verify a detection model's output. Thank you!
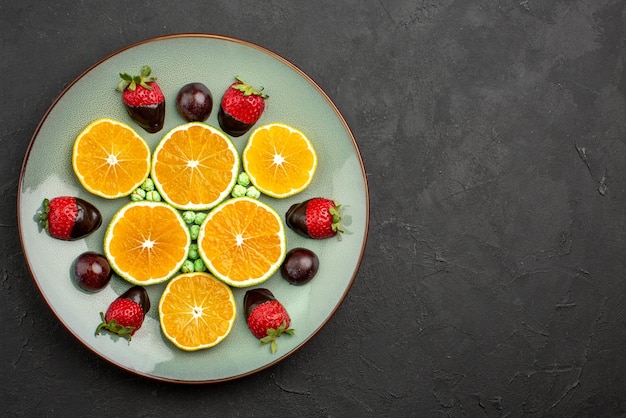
[104, 201, 191, 286]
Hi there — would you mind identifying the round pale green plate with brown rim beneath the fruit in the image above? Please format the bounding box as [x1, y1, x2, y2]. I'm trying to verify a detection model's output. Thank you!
[17, 34, 369, 383]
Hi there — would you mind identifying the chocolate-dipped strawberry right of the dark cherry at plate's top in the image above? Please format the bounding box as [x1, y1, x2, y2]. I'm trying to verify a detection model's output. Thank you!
[217, 77, 269, 136]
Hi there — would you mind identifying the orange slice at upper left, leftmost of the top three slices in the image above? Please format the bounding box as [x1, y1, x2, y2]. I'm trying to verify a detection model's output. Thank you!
[72, 118, 150, 199]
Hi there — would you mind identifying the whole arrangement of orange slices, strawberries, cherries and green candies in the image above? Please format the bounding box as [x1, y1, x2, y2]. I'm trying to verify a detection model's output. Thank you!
[38, 66, 343, 353]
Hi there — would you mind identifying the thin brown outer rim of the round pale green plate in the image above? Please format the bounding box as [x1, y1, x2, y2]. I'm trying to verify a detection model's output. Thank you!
[16, 32, 370, 384]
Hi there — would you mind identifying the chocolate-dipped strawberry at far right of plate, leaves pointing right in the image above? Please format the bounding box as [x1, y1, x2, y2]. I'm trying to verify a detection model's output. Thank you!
[285, 197, 343, 239]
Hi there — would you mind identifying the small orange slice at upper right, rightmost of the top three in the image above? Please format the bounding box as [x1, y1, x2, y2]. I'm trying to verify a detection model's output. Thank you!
[242, 123, 317, 198]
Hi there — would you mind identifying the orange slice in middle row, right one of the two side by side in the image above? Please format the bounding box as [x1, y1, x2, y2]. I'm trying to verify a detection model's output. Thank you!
[198, 197, 286, 287]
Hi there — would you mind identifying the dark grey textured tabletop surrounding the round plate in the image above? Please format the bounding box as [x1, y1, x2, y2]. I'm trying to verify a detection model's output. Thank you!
[0, 0, 626, 417]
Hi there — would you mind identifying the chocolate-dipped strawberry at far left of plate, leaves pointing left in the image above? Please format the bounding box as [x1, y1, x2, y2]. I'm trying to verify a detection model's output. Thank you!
[38, 196, 102, 241]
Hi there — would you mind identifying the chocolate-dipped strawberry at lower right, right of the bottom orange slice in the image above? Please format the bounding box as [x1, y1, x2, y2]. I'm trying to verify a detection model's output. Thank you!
[244, 288, 294, 353]
